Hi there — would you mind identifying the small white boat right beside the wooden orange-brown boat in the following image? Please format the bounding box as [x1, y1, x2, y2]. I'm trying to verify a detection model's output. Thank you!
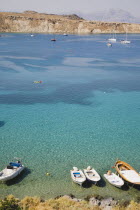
[104, 171, 124, 188]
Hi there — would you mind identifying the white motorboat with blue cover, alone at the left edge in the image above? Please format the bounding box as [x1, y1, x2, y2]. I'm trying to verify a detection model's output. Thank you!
[0, 161, 25, 181]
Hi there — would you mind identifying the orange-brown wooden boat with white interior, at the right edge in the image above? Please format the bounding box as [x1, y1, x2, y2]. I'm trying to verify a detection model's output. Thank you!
[115, 160, 140, 185]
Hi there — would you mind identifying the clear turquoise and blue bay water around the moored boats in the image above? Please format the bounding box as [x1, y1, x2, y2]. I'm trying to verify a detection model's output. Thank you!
[0, 34, 140, 199]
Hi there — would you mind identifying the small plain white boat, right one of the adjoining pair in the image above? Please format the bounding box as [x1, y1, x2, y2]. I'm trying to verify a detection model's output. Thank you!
[84, 166, 101, 183]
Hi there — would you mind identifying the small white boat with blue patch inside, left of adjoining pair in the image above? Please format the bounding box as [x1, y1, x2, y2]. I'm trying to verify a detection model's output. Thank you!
[70, 167, 86, 185]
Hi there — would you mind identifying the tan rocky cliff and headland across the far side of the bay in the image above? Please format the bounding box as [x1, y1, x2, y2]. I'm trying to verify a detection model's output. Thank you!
[0, 12, 140, 34]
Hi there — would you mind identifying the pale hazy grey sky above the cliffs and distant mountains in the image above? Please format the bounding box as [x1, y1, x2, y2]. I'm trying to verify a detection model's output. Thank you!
[0, 0, 140, 16]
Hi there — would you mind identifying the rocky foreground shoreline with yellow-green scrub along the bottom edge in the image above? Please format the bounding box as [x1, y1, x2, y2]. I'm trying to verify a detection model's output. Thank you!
[0, 195, 140, 210]
